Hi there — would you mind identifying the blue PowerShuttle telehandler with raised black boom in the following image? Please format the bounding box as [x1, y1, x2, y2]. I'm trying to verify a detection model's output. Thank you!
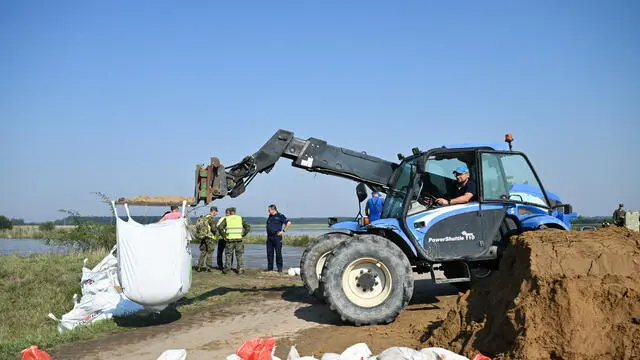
[195, 130, 577, 325]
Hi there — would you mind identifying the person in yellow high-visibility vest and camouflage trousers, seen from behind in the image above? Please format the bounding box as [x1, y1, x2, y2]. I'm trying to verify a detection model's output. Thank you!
[218, 207, 251, 274]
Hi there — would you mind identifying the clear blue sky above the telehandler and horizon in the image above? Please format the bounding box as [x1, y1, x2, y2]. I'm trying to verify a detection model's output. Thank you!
[0, 0, 640, 221]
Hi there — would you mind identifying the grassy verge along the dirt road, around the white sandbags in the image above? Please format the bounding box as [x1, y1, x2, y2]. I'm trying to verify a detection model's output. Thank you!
[0, 251, 299, 359]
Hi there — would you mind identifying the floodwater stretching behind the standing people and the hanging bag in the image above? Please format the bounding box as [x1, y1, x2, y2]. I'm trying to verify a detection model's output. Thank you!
[0, 239, 304, 270]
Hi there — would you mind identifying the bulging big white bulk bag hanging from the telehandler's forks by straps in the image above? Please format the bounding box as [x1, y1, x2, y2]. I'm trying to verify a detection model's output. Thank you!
[112, 203, 191, 309]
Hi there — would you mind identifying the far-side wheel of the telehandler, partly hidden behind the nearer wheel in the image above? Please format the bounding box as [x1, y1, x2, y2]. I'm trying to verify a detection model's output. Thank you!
[300, 233, 351, 300]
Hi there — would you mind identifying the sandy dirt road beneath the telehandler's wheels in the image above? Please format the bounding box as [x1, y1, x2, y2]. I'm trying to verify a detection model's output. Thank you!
[52, 276, 457, 360]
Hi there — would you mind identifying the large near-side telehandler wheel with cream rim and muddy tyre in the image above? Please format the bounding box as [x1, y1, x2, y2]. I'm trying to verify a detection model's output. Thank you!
[320, 234, 413, 326]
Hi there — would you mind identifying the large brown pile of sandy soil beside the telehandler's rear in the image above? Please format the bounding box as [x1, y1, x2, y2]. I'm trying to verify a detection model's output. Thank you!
[426, 228, 640, 360]
